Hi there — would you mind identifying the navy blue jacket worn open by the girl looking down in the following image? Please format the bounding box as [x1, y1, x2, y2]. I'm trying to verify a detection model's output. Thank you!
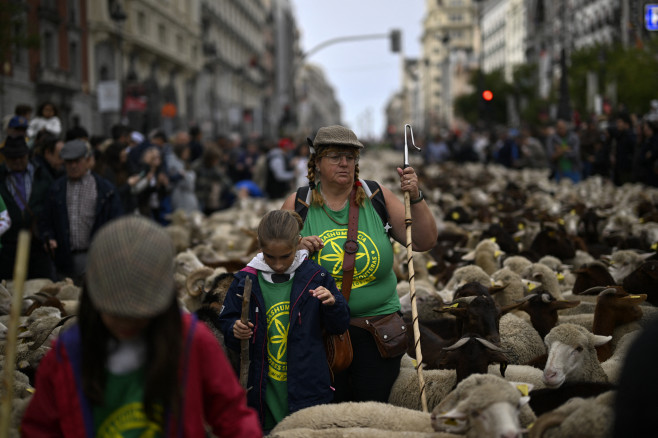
[219, 260, 350, 424]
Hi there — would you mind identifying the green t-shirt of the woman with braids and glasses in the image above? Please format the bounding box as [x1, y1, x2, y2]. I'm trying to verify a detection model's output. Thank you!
[302, 199, 400, 317]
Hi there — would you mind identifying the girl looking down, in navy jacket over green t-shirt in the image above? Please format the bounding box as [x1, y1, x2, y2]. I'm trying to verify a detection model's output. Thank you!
[220, 210, 350, 431]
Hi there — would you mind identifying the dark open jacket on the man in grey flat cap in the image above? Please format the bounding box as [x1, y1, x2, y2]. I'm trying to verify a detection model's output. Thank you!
[39, 172, 123, 272]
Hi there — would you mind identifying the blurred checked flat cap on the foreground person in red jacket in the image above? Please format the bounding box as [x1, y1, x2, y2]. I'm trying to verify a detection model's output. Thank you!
[86, 216, 175, 318]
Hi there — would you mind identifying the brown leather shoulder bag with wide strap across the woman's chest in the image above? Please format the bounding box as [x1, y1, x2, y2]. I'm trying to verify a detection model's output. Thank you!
[323, 188, 359, 381]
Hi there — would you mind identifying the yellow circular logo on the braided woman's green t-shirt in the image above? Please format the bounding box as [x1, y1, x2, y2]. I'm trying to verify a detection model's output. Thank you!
[314, 229, 380, 290]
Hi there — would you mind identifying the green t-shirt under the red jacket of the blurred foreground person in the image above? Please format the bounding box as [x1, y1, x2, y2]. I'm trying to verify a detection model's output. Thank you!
[93, 368, 164, 438]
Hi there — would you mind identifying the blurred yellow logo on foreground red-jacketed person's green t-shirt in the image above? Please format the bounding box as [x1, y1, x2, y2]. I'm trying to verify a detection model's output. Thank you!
[96, 402, 163, 438]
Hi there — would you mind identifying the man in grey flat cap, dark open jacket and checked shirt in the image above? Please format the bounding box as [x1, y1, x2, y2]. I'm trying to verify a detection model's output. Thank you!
[40, 140, 123, 284]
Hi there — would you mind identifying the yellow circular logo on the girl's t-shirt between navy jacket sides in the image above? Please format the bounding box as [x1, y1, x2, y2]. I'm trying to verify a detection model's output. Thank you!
[266, 301, 290, 382]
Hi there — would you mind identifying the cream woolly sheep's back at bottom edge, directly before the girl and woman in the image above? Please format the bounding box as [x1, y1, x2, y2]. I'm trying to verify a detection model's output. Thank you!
[269, 401, 446, 438]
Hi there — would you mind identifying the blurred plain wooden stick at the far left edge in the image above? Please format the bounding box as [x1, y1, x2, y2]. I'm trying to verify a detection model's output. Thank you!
[0, 230, 30, 438]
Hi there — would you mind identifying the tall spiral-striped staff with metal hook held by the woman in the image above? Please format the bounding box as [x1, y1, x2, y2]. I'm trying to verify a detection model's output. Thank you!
[403, 124, 427, 412]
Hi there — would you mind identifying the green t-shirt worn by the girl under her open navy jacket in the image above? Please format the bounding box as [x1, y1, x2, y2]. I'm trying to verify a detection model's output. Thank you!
[258, 272, 293, 430]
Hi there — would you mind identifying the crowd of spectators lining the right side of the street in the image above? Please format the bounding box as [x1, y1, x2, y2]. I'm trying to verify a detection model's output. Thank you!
[416, 108, 658, 187]
